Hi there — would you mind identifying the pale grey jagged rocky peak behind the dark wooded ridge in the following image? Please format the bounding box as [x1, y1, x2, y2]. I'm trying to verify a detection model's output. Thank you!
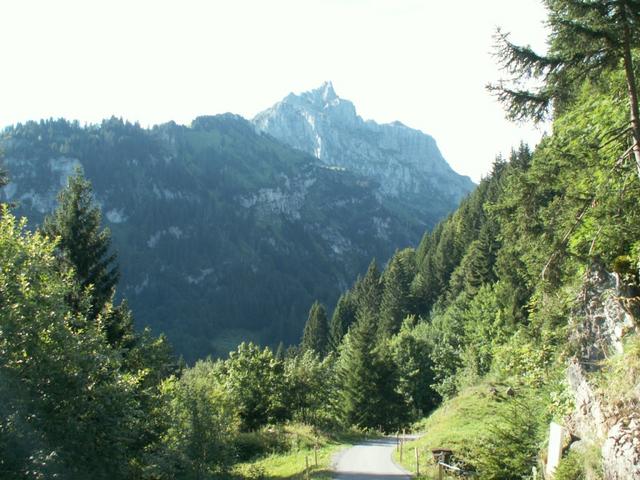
[253, 82, 474, 227]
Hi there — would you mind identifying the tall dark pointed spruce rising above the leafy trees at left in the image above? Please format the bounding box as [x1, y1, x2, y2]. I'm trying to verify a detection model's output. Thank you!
[43, 169, 119, 319]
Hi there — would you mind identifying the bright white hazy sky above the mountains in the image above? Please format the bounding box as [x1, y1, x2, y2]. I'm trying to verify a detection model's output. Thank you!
[0, 0, 545, 180]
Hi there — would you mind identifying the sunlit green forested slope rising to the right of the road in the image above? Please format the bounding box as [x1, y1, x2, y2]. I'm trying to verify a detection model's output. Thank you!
[302, 56, 640, 478]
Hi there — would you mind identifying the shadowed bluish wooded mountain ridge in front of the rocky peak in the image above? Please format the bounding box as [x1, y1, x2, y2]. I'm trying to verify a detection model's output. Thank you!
[1, 115, 455, 359]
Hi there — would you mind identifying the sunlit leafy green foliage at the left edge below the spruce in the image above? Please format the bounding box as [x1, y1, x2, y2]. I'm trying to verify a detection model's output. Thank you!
[0, 210, 144, 478]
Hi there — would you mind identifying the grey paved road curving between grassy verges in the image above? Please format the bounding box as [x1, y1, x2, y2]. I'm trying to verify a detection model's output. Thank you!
[333, 438, 411, 480]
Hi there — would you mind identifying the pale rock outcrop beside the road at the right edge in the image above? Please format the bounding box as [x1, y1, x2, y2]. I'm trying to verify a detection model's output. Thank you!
[567, 267, 640, 480]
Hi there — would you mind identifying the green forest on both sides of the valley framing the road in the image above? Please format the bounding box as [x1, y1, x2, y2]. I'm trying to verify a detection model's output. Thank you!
[0, 0, 640, 479]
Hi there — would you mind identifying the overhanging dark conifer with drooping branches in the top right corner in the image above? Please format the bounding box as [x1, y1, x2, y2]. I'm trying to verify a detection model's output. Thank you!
[489, 0, 640, 175]
